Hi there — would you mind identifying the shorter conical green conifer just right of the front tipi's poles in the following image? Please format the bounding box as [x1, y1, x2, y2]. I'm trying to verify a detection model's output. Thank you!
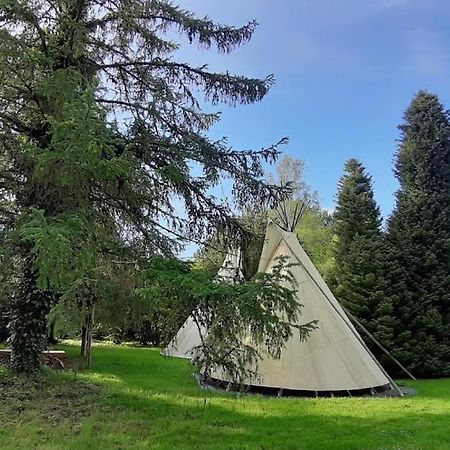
[334, 159, 391, 345]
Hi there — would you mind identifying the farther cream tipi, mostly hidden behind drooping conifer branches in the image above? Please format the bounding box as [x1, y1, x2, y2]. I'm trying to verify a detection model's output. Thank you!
[162, 250, 244, 359]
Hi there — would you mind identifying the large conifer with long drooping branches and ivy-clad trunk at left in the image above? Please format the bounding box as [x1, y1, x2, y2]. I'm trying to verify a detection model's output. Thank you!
[0, 0, 284, 372]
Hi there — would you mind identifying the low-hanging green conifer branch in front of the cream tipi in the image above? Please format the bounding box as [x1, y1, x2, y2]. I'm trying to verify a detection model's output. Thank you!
[139, 258, 315, 382]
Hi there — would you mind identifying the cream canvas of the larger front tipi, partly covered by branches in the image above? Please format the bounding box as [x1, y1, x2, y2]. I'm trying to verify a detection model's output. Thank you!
[206, 216, 398, 394]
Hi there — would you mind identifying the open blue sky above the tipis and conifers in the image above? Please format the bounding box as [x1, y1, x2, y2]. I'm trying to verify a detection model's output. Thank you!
[176, 0, 450, 221]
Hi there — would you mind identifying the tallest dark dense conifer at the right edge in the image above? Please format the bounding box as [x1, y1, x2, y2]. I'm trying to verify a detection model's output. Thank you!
[388, 91, 450, 376]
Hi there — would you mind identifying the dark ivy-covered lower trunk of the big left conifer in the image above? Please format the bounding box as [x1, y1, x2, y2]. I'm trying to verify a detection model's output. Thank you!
[9, 255, 52, 374]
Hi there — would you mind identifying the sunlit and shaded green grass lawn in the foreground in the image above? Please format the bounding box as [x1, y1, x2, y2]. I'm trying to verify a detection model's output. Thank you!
[0, 346, 450, 450]
